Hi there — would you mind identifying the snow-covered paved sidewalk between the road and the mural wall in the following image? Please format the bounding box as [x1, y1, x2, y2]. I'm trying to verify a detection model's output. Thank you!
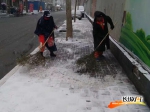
[0, 18, 150, 112]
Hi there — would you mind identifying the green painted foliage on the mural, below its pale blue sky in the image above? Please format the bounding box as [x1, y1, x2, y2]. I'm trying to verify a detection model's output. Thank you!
[119, 12, 150, 67]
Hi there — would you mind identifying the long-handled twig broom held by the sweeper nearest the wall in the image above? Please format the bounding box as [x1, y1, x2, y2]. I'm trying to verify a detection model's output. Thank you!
[76, 23, 117, 73]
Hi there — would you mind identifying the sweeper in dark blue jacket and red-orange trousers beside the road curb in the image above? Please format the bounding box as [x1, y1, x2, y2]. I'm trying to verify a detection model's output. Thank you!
[34, 11, 57, 57]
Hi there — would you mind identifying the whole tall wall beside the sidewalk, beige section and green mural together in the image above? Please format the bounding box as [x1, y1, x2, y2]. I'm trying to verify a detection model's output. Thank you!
[85, 0, 150, 67]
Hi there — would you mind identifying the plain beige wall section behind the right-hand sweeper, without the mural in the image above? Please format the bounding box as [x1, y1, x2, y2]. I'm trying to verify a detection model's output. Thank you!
[85, 0, 126, 41]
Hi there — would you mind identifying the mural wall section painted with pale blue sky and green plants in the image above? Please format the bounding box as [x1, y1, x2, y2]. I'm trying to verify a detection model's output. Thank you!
[119, 0, 150, 67]
